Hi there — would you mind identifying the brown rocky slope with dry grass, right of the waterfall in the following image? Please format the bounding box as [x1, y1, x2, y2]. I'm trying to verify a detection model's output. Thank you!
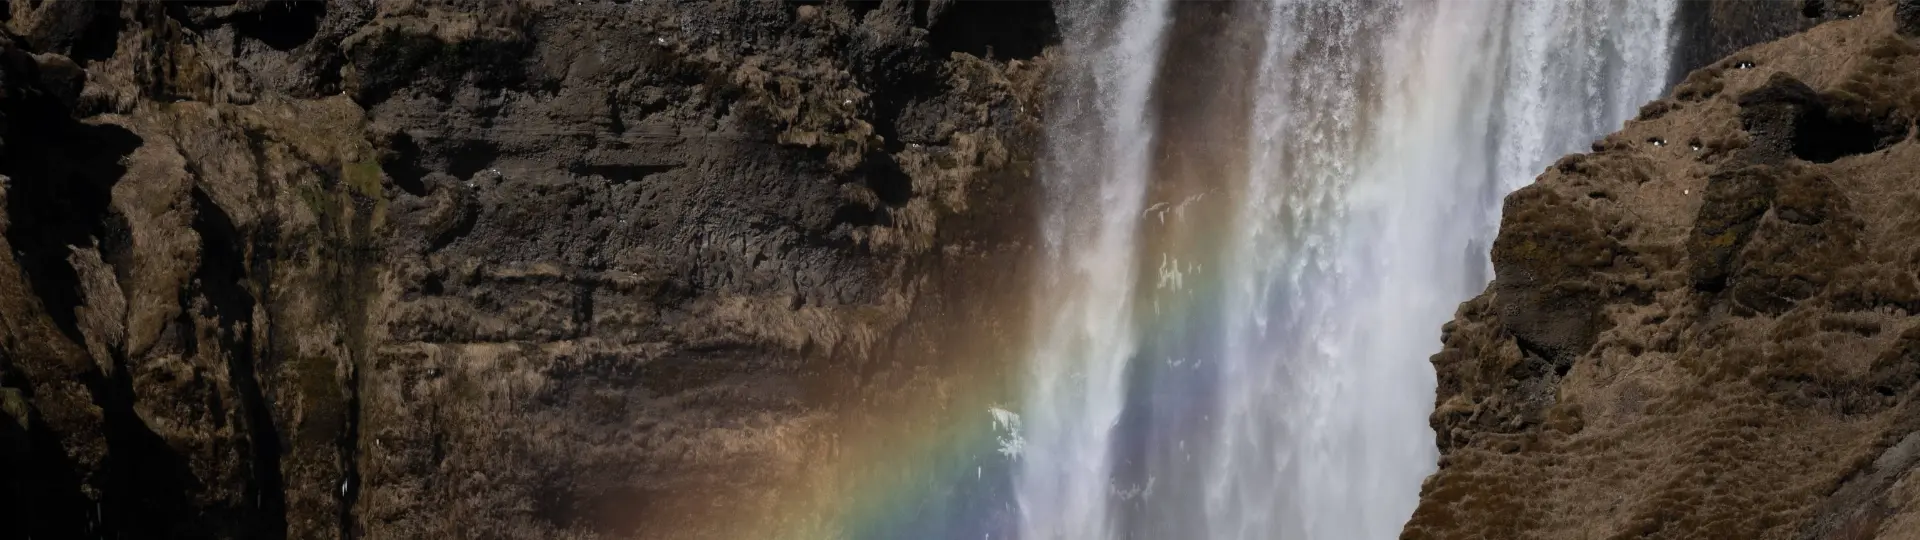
[1404, 2, 1920, 538]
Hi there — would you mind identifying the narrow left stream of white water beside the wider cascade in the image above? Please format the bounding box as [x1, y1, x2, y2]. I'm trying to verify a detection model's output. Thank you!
[1014, 0, 1167, 538]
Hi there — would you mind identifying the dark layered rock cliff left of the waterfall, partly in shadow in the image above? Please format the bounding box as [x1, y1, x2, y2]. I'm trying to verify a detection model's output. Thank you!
[0, 0, 1054, 538]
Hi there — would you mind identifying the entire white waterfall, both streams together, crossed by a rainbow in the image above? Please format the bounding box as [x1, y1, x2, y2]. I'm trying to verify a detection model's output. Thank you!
[1014, 0, 1676, 540]
